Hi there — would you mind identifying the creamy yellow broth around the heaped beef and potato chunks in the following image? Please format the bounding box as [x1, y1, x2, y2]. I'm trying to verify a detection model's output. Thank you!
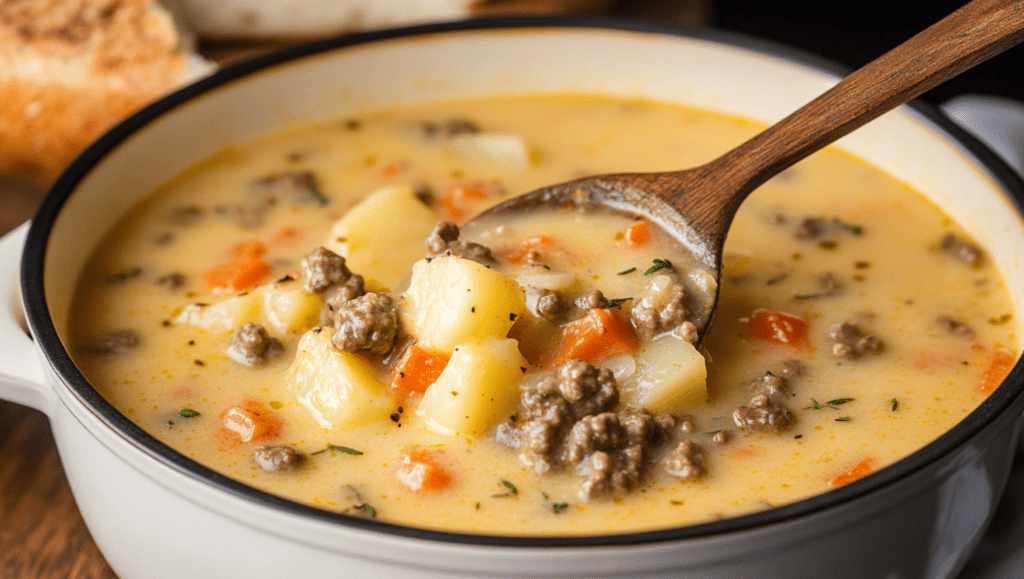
[71, 96, 1019, 535]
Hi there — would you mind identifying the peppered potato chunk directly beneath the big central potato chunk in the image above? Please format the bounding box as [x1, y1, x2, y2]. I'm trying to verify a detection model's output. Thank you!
[416, 338, 526, 436]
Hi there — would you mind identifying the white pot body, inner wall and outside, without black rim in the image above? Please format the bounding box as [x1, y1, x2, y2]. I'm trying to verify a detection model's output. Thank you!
[0, 18, 1024, 579]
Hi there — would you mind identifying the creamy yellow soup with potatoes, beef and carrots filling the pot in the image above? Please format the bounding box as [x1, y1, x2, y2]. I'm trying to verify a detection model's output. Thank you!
[71, 95, 1020, 536]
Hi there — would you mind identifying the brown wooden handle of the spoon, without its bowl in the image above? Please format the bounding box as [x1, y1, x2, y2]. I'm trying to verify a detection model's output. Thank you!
[672, 0, 1024, 240]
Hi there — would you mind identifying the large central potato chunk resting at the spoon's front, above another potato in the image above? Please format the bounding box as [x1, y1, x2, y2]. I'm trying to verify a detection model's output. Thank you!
[402, 255, 526, 353]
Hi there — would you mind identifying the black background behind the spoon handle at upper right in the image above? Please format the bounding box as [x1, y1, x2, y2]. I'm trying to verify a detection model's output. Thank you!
[688, 0, 1024, 104]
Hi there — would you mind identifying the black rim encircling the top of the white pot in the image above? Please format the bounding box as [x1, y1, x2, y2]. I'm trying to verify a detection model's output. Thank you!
[22, 15, 1024, 548]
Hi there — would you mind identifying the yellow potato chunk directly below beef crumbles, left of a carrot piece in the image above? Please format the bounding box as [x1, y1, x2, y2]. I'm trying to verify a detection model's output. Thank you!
[287, 328, 395, 429]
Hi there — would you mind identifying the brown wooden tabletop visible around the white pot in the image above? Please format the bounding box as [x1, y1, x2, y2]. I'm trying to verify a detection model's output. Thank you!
[0, 0, 709, 579]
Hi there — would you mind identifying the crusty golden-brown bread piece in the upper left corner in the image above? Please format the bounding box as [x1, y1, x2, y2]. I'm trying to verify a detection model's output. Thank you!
[0, 0, 213, 188]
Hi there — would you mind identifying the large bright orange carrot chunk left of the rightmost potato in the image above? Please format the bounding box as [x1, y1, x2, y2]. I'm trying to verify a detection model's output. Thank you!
[543, 308, 637, 366]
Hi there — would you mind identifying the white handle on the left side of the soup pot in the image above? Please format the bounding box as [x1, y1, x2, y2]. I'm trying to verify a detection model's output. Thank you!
[0, 222, 53, 415]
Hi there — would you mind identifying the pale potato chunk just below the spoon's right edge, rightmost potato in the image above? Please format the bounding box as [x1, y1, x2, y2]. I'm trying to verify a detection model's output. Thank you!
[620, 334, 708, 412]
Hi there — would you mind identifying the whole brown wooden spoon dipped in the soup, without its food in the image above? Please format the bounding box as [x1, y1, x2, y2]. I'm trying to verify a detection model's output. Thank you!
[467, 0, 1024, 338]
